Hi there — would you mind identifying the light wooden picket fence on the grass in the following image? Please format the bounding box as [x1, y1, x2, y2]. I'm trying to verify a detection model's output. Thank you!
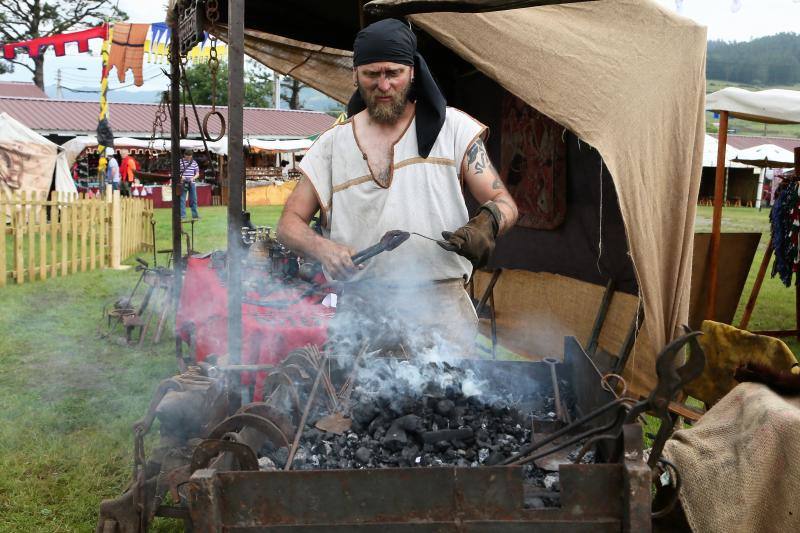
[0, 191, 153, 287]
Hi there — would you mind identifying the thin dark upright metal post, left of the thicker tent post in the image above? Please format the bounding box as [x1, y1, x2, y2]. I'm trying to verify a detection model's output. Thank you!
[169, 16, 183, 359]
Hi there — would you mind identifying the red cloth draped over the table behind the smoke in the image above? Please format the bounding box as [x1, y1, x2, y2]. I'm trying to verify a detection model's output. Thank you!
[175, 230, 335, 401]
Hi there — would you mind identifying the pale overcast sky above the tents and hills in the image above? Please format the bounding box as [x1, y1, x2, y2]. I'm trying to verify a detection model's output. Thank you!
[0, 0, 800, 91]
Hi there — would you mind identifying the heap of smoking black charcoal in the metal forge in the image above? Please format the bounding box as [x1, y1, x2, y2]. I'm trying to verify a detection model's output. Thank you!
[261, 359, 552, 480]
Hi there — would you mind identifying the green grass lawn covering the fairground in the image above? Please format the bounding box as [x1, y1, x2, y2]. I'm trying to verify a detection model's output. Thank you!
[0, 203, 797, 532]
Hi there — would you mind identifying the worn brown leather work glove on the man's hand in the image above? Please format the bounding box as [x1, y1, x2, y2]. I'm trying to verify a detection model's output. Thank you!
[439, 202, 500, 268]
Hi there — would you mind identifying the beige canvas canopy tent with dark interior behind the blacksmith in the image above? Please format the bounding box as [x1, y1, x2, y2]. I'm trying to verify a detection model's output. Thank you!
[202, 0, 706, 392]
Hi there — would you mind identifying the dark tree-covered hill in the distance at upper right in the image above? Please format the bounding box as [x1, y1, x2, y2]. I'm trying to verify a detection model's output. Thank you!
[706, 33, 800, 86]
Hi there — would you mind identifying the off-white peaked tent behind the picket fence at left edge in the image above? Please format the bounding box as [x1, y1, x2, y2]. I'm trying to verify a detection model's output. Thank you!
[0, 113, 76, 193]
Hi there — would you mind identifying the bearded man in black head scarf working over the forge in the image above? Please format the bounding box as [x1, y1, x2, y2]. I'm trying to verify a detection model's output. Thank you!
[278, 19, 517, 355]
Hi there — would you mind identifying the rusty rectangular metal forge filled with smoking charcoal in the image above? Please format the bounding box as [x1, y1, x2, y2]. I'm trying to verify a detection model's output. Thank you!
[183, 339, 650, 532]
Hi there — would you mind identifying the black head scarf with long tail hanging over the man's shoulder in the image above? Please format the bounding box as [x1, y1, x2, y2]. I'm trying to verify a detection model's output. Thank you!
[347, 19, 447, 157]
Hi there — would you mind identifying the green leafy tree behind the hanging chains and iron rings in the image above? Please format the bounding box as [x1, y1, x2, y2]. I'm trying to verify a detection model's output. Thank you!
[186, 61, 272, 107]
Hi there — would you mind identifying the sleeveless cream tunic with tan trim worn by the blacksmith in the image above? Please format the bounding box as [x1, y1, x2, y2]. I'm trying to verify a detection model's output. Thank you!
[300, 107, 486, 284]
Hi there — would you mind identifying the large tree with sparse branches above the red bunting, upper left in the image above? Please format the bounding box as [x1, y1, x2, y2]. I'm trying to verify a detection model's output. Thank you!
[0, 0, 128, 90]
